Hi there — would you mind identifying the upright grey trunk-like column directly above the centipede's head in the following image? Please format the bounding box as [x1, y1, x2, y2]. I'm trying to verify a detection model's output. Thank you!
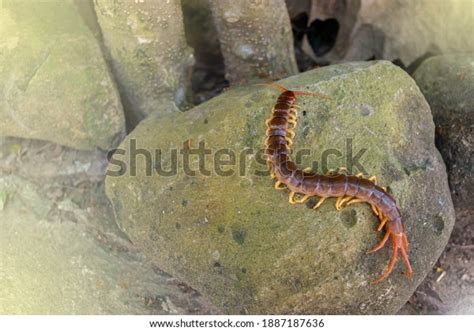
[209, 0, 298, 84]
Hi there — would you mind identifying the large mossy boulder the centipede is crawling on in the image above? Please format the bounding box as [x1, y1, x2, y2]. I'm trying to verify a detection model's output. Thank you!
[106, 62, 454, 314]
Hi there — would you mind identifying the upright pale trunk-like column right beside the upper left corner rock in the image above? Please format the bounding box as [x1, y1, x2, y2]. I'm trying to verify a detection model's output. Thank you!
[95, 0, 193, 124]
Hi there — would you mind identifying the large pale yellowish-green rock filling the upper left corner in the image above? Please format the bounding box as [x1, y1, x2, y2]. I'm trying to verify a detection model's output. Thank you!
[0, 0, 125, 149]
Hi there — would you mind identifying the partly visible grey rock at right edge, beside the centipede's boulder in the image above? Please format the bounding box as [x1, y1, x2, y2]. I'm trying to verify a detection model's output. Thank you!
[413, 55, 474, 231]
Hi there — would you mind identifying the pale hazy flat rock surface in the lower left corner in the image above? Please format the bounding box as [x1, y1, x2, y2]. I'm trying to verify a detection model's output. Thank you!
[0, 138, 215, 314]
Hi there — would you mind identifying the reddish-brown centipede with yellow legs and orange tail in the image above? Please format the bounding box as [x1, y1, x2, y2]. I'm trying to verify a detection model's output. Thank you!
[258, 84, 413, 284]
